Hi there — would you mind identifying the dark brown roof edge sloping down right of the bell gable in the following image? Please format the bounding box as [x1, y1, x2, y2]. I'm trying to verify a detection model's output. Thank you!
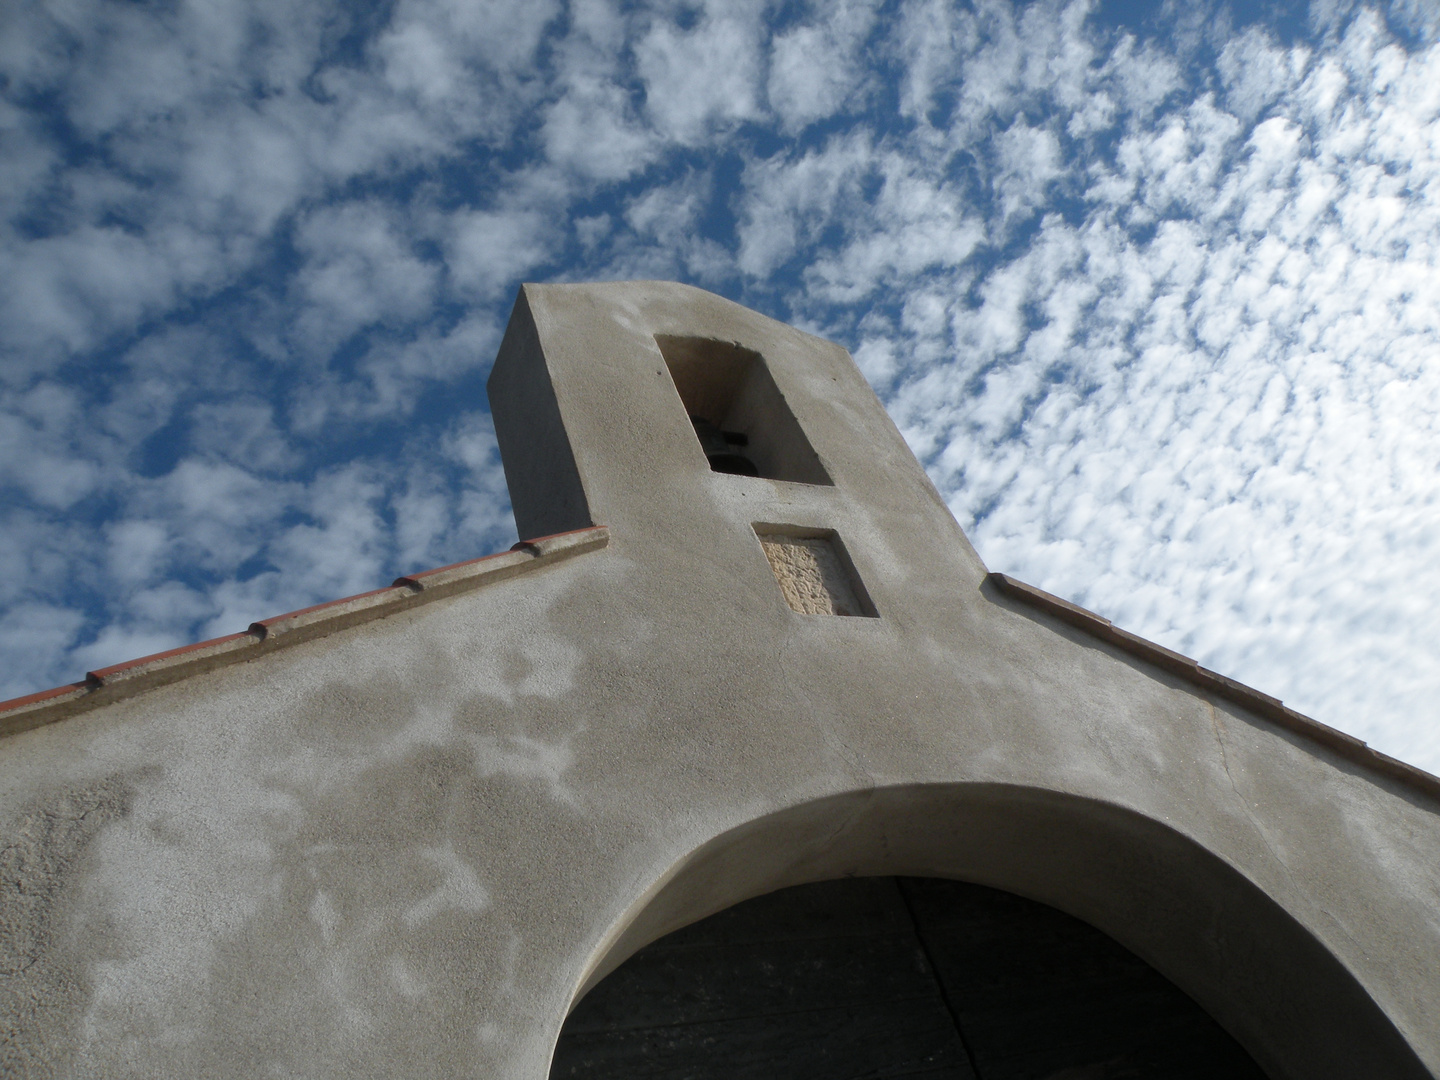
[988, 570, 1440, 798]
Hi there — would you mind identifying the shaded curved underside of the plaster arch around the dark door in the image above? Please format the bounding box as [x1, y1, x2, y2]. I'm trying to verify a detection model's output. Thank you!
[572, 783, 1430, 1080]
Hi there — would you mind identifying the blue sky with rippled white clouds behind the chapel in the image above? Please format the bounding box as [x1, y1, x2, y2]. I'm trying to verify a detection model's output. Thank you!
[0, 0, 1440, 770]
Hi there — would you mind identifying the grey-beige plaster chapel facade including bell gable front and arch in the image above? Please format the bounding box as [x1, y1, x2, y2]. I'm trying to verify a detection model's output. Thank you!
[0, 282, 1440, 1080]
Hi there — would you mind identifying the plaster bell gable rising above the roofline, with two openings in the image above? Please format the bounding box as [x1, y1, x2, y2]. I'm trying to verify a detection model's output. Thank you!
[490, 282, 985, 639]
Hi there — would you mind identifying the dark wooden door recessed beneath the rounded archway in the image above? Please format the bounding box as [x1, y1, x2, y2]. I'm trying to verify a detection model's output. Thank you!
[550, 877, 1264, 1080]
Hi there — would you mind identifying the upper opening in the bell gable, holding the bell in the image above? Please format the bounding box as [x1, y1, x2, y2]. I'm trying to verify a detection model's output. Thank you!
[655, 334, 832, 484]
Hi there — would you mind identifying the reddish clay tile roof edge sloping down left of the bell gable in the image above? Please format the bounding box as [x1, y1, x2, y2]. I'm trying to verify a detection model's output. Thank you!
[0, 526, 609, 739]
